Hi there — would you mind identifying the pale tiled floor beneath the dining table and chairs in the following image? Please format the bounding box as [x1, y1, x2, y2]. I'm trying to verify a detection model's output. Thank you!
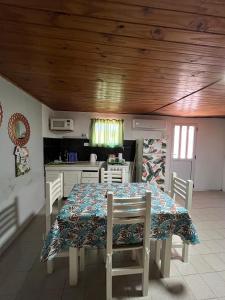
[0, 192, 225, 300]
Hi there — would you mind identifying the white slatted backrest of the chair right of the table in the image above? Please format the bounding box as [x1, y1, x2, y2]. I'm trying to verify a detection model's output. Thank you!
[171, 172, 193, 210]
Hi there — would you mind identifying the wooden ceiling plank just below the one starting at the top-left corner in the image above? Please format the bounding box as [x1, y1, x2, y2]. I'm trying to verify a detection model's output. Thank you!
[0, 4, 225, 48]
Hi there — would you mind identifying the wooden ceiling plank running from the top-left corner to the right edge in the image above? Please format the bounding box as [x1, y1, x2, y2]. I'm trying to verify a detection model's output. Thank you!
[0, 0, 225, 33]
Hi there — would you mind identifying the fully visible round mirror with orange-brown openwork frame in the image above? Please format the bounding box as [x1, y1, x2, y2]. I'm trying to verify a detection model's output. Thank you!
[8, 113, 30, 147]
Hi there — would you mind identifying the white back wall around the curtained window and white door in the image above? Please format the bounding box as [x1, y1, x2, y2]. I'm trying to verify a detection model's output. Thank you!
[44, 111, 225, 191]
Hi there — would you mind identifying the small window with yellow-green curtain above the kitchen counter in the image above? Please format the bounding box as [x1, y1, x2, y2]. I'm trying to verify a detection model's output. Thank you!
[90, 119, 124, 147]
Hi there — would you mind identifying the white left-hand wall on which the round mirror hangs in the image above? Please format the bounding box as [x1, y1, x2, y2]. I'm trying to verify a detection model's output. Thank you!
[0, 78, 44, 247]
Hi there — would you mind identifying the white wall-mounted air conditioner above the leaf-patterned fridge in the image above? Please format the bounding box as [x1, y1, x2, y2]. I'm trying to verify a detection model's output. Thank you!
[133, 119, 166, 131]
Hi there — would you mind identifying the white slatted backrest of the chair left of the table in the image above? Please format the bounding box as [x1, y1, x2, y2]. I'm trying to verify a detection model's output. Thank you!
[46, 173, 63, 233]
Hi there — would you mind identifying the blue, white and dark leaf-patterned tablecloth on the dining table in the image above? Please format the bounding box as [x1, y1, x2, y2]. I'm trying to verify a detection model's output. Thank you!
[41, 183, 199, 261]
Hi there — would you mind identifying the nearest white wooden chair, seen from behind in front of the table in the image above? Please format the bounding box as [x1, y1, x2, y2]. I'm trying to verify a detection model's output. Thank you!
[106, 191, 151, 300]
